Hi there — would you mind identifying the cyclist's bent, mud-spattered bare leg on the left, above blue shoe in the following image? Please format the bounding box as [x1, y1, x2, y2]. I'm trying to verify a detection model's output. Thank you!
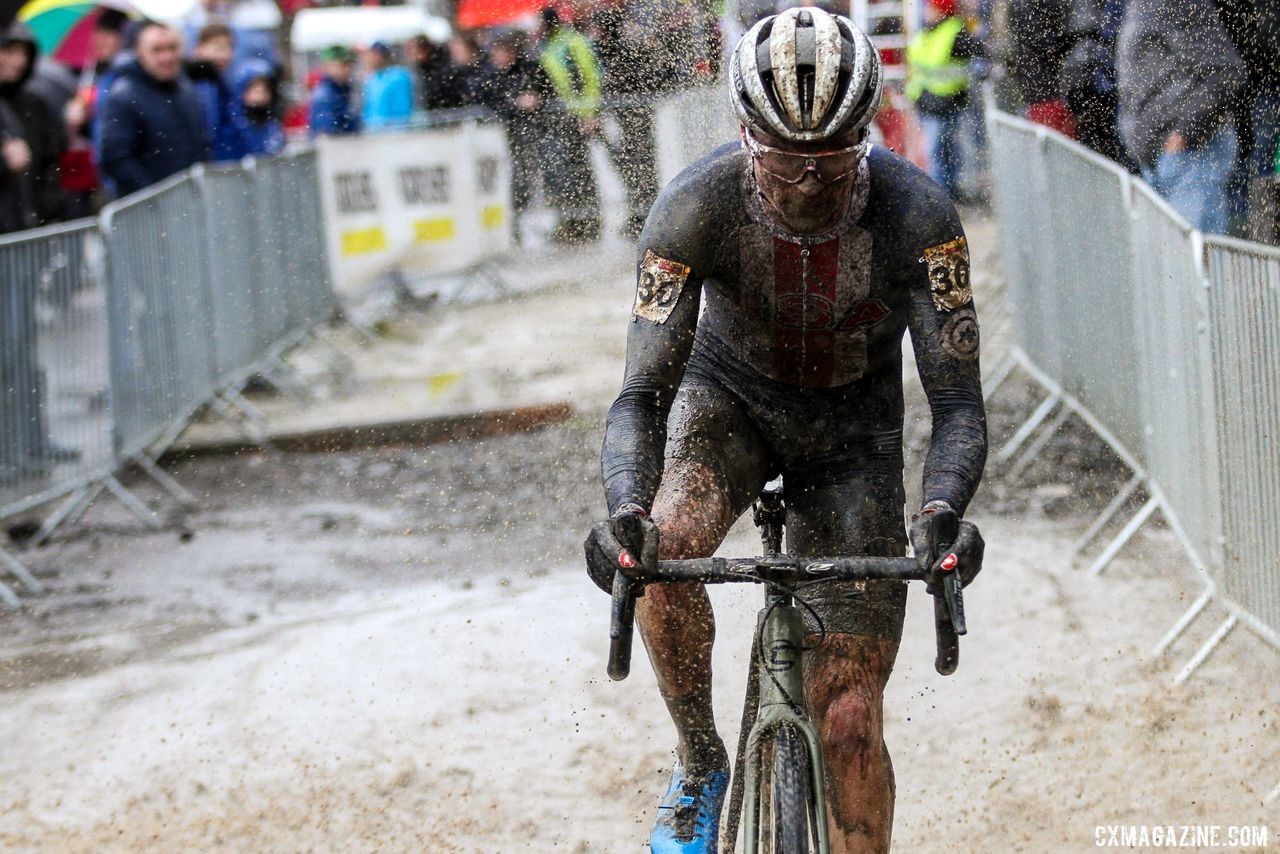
[636, 375, 768, 776]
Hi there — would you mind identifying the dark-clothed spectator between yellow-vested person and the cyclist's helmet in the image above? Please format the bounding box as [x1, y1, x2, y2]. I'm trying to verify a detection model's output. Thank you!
[593, 3, 675, 238]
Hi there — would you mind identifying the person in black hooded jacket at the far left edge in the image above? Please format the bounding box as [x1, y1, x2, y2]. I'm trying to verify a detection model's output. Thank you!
[0, 22, 67, 225]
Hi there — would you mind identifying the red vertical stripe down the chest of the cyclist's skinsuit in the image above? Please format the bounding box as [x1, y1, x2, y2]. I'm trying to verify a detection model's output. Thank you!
[773, 238, 840, 387]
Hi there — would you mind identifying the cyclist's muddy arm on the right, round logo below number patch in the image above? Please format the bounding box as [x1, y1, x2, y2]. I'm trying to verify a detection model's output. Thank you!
[908, 208, 987, 513]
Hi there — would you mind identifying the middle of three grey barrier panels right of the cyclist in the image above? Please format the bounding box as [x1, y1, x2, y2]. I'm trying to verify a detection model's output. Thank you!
[1133, 182, 1221, 567]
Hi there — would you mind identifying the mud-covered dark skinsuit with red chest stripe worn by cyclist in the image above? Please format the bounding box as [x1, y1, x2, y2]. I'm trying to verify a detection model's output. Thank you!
[602, 146, 987, 638]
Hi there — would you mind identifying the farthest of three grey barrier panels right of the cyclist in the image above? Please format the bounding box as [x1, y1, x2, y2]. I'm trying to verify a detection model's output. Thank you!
[1033, 140, 1143, 455]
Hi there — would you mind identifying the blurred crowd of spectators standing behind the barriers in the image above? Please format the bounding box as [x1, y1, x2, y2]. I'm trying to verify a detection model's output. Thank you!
[0, 0, 1280, 242]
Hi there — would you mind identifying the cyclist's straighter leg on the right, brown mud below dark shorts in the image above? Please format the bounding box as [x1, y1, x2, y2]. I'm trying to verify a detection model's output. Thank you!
[787, 474, 906, 854]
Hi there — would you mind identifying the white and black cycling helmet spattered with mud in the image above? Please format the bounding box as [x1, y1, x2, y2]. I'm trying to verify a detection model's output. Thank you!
[730, 6, 884, 142]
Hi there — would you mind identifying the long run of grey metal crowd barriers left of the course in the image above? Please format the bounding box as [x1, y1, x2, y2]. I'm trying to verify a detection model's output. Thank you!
[0, 151, 337, 606]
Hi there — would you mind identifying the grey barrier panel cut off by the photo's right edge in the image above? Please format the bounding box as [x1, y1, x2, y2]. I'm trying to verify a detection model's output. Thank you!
[1206, 238, 1280, 631]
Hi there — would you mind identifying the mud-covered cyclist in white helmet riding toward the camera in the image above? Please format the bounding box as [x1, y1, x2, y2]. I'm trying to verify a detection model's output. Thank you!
[586, 8, 987, 854]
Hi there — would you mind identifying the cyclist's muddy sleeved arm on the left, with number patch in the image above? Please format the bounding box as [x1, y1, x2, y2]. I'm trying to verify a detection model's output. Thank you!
[600, 213, 701, 515]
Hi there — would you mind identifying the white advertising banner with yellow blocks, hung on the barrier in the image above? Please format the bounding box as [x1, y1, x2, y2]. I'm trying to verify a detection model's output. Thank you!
[319, 123, 511, 300]
